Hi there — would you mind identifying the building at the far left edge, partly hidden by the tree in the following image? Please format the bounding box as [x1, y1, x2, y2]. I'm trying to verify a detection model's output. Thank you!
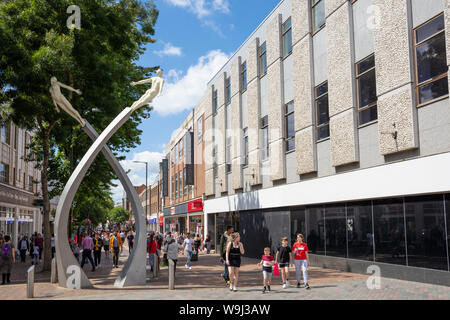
[0, 121, 43, 245]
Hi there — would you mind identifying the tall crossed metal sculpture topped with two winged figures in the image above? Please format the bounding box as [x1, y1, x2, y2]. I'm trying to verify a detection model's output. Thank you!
[50, 70, 164, 289]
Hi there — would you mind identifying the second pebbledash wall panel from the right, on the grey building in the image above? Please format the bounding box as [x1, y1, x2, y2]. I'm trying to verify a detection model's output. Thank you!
[327, 2, 359, 167]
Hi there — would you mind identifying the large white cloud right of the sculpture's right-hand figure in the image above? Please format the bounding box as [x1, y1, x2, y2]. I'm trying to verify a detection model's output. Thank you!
[152, 50, 231, 116]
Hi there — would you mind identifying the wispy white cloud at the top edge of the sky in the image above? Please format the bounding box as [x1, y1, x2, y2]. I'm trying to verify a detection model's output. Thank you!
[165, 0, 230, 19]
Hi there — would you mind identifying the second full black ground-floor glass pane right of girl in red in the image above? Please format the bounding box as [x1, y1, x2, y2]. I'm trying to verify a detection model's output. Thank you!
[325, 205, 347, 258]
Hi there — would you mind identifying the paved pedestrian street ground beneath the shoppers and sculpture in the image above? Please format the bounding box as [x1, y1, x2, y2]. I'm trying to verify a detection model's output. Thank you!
[0, 244, 450, 300]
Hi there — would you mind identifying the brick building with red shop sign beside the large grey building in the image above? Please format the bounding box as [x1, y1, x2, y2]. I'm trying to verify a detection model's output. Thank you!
[160, 101, 205, 236]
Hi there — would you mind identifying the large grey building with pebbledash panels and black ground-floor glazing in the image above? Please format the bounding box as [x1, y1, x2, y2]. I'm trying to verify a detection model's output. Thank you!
[195, 0, 450, 285]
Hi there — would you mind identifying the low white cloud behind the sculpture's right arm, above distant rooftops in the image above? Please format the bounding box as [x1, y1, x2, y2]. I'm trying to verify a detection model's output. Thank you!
[111, 151, 164, 203]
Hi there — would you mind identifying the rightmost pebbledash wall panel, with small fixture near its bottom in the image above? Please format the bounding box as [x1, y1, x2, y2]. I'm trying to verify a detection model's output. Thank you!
[373, 0, 418, 155]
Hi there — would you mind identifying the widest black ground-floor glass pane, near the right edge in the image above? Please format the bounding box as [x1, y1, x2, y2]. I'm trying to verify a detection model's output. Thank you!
[405, 195, 448, 271]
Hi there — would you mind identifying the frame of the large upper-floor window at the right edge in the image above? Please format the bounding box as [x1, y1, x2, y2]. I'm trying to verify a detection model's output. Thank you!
[412, 12, 450, 107]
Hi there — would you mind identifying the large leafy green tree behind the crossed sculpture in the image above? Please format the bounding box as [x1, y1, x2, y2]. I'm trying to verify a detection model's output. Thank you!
[0, 0, 158, 270]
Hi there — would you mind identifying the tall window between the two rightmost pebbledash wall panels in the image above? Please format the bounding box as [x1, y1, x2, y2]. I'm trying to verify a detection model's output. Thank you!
[356, 54, 378, 125]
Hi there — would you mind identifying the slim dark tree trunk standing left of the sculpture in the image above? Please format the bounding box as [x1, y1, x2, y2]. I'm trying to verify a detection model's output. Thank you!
[41, 129, 52, 271]
